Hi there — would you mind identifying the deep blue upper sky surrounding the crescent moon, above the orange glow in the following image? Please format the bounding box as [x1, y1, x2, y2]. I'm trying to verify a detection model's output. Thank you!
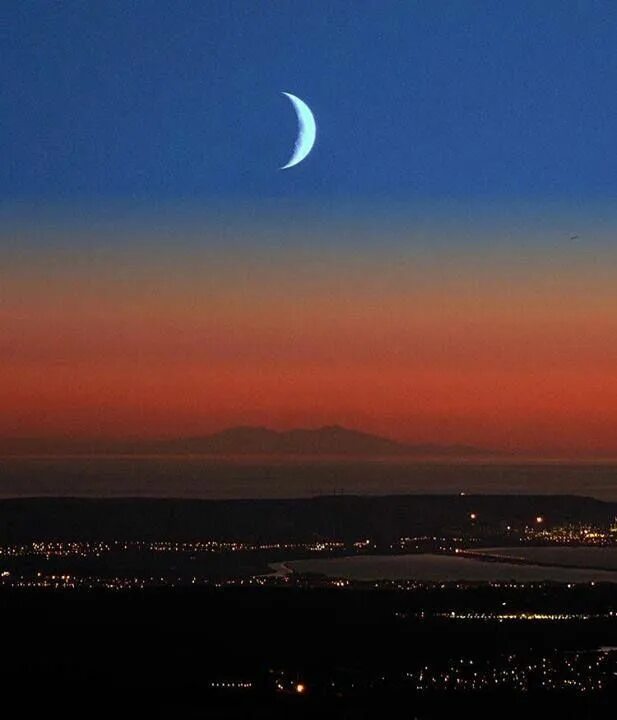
[0, 0, 617, 204]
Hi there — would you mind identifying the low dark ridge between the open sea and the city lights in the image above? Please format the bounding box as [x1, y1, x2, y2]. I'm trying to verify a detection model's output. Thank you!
[0, 495, 617, 543]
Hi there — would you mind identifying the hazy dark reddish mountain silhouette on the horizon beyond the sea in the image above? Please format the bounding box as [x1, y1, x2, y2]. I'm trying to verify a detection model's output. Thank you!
[0, 425, 490, 457]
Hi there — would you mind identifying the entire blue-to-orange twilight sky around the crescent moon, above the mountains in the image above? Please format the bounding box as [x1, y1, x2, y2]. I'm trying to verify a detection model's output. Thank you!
[0, 0, 617, 455]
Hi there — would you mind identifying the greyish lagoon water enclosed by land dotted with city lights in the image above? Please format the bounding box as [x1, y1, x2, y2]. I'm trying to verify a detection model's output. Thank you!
[285, 548, 617, 583]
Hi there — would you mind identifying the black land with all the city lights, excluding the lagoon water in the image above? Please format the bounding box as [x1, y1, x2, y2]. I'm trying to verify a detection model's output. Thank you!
[0, 495, 617, 720]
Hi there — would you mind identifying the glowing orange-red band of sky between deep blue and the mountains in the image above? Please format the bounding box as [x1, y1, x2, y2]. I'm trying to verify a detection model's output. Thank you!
[0, 208, 617, 453]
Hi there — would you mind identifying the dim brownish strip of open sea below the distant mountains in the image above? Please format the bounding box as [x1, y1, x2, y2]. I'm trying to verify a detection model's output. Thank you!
[0, 456, 617, 501]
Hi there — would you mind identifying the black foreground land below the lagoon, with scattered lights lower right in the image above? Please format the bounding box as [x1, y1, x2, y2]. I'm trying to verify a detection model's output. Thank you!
[0, 588, 617, 718]
